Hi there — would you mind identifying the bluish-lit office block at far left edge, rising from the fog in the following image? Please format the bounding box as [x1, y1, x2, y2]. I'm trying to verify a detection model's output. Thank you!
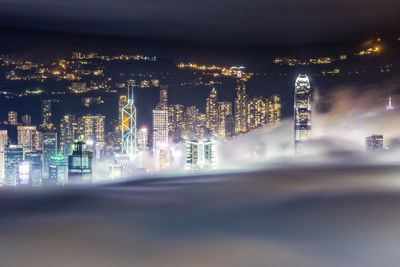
[4, 145, 24, 186]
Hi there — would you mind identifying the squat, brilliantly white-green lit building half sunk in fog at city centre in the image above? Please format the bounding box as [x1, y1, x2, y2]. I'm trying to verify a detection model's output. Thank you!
[186, 140, 217, 171]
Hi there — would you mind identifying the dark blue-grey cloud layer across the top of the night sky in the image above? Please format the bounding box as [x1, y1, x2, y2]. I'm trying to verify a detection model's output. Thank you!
[0, 0, 400, 44]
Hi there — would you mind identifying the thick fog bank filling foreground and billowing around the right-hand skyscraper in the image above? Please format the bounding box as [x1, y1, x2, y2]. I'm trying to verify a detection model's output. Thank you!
[0, 83, 400, 267]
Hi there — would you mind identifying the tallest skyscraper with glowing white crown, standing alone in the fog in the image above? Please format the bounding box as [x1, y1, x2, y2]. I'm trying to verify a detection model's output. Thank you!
[294, 74, 312, 152]
